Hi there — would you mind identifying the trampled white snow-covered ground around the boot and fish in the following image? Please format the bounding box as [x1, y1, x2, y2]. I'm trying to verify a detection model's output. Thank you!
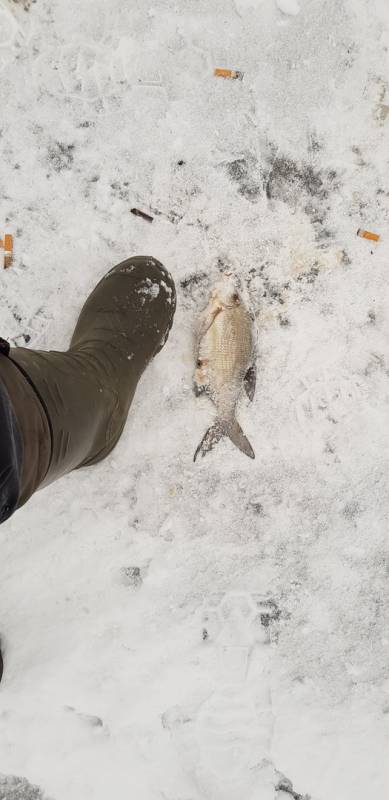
[0, 0, 389, 800]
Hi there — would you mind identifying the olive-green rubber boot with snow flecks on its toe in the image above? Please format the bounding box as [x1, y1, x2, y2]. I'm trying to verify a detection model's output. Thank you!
[0, 256, 176, 508]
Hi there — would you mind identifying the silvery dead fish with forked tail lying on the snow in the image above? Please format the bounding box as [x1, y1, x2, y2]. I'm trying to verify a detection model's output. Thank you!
[194, 273, 256, 461]
